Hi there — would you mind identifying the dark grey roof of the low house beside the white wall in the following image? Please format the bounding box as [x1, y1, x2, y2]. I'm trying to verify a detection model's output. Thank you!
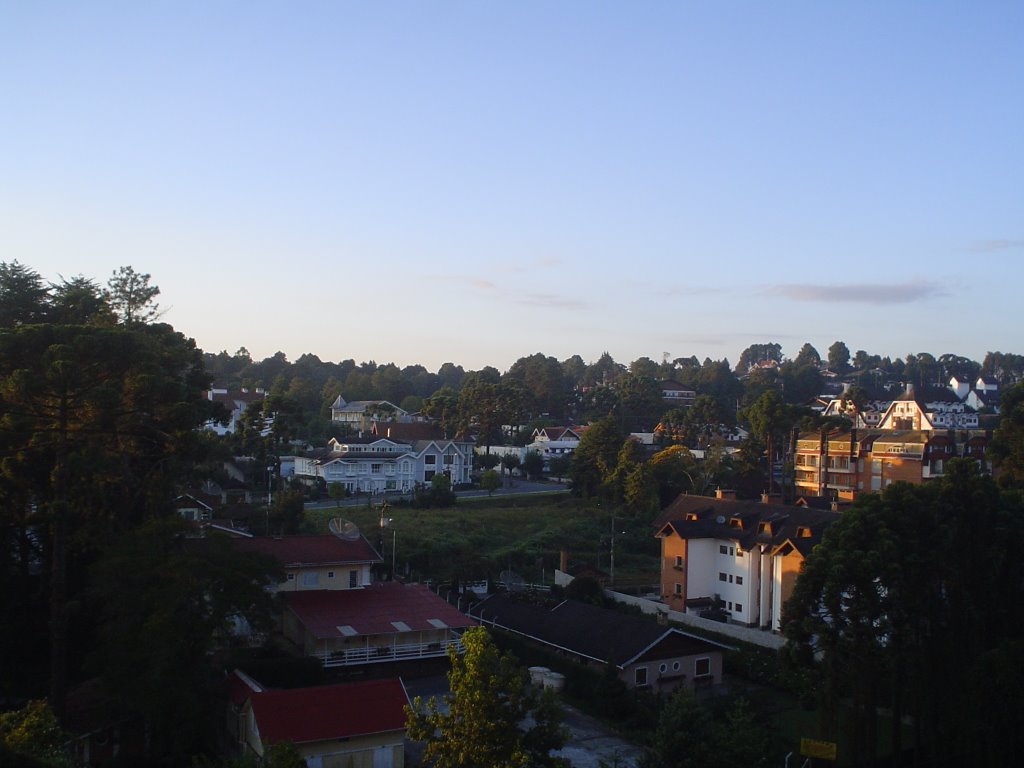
[469, 593, 727, 667]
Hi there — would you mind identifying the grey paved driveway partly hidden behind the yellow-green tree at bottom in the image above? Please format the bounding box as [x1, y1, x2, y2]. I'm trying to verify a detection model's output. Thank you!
[404, 676, 643, 768]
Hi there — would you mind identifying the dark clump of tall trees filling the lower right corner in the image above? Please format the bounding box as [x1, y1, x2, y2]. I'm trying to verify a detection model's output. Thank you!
[783, 460, 1024, 766]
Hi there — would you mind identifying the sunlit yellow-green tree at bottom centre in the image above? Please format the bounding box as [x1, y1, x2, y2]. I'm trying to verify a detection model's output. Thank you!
[406, 627, 566, 768]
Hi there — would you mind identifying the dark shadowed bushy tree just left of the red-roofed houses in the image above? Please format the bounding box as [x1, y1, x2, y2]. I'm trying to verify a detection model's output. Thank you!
[88, 516, 284, 764]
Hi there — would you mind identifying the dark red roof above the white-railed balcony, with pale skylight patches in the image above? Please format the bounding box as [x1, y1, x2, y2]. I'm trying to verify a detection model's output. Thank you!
[284, 582, 476, 639]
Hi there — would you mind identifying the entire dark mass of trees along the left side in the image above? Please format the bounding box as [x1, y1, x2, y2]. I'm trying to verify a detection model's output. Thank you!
[0, 262, 276, 764]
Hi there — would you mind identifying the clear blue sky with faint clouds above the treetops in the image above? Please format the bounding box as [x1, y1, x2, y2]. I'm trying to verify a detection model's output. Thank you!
[0, 0, 1024, 371]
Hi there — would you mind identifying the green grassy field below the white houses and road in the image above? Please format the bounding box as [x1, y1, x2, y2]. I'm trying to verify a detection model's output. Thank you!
[306, 494, 658, 585]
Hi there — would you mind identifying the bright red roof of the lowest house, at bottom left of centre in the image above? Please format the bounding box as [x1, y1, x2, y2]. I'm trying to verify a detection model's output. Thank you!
[251, 678, 409, 743]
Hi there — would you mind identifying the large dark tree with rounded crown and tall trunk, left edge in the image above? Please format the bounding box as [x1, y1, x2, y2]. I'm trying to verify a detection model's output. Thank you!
[0, 325, 218, 716]
